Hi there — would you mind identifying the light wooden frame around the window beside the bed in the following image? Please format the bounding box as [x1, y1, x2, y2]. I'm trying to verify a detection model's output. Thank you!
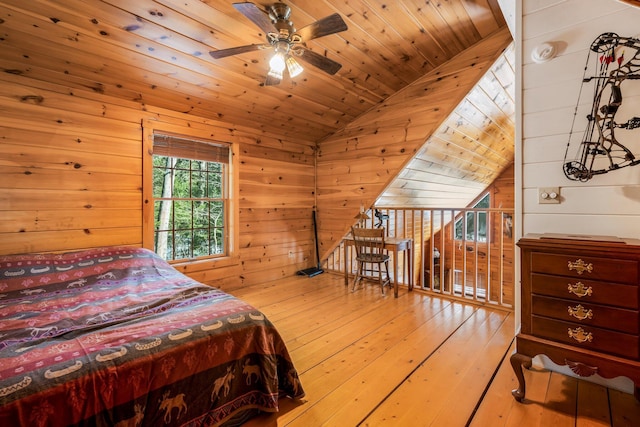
[142, 120, 239, 266]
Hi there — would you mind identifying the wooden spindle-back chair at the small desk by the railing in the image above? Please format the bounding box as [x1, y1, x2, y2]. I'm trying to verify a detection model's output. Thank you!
[351, 227, 391, 295]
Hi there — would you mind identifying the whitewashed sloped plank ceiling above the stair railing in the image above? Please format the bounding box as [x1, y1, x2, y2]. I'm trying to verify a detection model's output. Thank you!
[376, 43, 515, 208]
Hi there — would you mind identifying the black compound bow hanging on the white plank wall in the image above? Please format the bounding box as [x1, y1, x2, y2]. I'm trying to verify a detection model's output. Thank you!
[563, 33, 640, 181]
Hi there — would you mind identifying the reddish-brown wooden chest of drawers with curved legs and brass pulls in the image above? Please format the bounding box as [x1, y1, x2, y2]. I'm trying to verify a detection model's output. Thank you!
[511, 234, 640, 401]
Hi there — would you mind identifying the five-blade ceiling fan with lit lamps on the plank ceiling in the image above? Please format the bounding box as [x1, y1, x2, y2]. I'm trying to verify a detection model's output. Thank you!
[209, 2, 347, 85]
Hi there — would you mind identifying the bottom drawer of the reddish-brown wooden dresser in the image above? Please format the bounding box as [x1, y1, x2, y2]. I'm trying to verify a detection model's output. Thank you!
[531, 316, 638, 360]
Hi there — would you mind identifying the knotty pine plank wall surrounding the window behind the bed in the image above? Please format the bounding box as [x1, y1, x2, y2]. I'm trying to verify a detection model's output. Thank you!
[0, 72, 315, 290]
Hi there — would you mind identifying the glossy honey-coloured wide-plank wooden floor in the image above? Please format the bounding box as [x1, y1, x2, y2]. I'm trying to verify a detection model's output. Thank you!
[231, 273, 640, 427]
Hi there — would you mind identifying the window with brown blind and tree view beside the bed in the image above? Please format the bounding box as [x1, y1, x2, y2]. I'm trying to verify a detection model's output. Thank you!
[145, 132, 231, 261]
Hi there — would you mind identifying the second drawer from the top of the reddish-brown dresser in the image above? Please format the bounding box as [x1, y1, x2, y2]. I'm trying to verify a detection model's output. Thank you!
[531, 273, 638, 310]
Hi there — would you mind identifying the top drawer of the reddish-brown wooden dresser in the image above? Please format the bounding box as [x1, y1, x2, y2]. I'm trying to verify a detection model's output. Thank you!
[531, 252, 638, 284]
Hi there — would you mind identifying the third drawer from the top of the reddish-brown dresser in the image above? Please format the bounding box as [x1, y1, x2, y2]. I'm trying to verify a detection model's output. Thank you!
[531, 295, 640, 334]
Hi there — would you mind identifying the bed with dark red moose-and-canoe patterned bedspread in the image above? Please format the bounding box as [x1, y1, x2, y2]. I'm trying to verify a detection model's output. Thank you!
[0, 247, 304, 427]
